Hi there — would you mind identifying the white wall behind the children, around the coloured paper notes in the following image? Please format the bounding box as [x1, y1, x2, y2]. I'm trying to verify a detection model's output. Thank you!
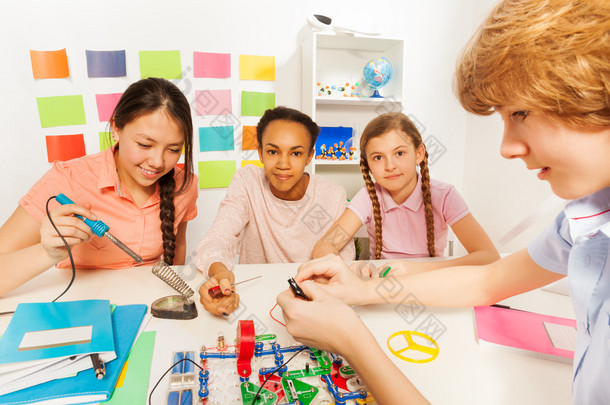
[0, 0, 550, 262]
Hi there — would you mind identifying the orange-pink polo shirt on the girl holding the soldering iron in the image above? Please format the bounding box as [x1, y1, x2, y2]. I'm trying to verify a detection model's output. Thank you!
[19, 149, 198, 269]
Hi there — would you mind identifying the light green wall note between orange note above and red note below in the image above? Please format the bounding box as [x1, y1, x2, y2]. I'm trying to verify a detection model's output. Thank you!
[36, 95, 87, 128]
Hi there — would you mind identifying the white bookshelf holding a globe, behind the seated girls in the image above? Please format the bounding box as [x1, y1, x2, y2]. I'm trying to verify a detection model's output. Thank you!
[301, 32, 405, 198]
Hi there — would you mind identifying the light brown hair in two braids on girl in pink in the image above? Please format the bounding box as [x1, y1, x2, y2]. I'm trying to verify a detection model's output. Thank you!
[360, 112, 436, 259]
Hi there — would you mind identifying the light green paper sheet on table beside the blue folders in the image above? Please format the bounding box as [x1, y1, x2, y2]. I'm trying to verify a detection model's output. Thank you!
[104, 330, 156, 405]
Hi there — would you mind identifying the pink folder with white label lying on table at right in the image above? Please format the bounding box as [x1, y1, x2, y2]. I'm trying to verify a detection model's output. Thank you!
[474, 305, 576, 363]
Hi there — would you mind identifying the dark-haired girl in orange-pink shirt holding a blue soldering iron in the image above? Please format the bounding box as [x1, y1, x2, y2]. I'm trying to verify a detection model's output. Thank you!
[0, 78, 198, 295]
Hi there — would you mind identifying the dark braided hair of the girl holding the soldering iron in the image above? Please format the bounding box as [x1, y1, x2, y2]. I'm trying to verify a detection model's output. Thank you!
[110, 77, 193, 264]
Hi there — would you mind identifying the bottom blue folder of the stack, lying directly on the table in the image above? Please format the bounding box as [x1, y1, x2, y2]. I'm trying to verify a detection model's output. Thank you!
[0, 304, 147, 405]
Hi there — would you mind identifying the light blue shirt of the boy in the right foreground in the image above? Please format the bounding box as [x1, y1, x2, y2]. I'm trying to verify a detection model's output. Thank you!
[528, 187, 610, 405]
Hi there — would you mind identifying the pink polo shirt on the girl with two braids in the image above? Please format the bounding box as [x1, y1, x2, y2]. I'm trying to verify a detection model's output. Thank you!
[348, 176, 470, 259]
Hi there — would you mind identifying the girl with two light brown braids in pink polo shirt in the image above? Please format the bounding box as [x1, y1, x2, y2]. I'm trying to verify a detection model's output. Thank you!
[313, 113, 499, 274]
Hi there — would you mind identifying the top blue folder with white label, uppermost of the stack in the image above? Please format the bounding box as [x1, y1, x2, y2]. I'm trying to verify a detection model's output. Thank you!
[0, 300, 114, 374]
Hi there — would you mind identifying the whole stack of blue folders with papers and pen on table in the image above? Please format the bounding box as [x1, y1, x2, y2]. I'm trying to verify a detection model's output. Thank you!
[0, 300, 147, 405]
